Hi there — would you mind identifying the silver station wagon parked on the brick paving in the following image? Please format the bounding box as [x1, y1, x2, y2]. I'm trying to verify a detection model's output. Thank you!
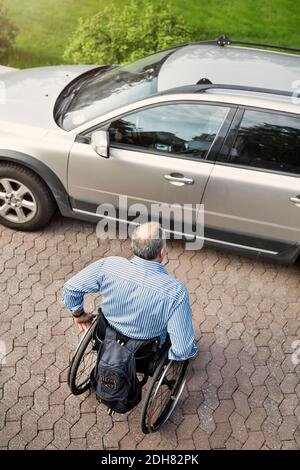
[0, 37, 300, 262]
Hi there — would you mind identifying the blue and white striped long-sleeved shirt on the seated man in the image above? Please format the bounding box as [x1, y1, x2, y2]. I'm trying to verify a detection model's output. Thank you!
[62, 256, 198, 361]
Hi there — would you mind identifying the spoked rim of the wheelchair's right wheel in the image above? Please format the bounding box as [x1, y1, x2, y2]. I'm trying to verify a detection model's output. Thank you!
[145, 361, 187, 432]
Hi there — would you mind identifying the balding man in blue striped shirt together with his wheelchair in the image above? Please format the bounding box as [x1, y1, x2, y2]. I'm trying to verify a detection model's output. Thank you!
[63, 222, 198, 432]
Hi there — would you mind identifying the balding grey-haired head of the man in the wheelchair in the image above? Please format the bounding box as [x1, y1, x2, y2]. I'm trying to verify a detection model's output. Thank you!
[131, 222, 166, 263]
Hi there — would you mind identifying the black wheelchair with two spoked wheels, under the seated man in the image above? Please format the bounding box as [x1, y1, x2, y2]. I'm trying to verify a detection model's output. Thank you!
[68, 310, 189, 434]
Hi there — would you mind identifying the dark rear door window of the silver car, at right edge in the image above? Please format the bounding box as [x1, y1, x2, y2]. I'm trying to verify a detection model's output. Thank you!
[229, 110, 300, 174]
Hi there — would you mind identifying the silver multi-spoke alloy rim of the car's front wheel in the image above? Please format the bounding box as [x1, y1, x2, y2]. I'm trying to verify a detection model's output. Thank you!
[0, 178, 37, 224]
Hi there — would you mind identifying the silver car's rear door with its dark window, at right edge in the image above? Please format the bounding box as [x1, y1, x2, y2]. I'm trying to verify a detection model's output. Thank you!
[203, 108, 300, 254]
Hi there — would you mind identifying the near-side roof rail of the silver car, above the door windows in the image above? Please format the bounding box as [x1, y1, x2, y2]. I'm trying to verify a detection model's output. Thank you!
[159, 83, 294, 96]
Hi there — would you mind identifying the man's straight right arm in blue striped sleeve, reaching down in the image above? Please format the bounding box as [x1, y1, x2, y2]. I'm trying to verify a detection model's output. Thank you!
[167, 289, 198, 361]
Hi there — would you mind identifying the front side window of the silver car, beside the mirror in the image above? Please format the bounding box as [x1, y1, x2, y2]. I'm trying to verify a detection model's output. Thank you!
[109, 103, 229, 158]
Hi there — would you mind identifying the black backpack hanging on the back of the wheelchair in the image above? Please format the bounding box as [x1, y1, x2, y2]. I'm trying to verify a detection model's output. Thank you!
[91, 326, 143, 413]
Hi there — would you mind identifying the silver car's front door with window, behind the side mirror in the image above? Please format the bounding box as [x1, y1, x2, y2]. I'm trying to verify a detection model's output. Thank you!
[68, 101, 235, 235]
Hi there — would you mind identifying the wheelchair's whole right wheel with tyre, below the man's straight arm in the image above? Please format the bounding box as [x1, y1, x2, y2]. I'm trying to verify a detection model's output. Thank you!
[141, 351, 189, 434]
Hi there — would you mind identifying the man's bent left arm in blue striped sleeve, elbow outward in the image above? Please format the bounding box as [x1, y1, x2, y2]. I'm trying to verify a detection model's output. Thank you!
[62, 259, 104, 314]
